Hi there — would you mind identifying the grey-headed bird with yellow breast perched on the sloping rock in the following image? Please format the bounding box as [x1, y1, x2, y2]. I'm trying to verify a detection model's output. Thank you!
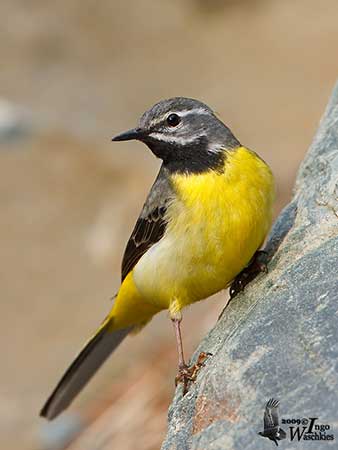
[40, 97, 275, 420]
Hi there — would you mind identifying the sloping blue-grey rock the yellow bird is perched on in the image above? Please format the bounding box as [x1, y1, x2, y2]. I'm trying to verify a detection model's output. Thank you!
[162, 84, 338, 450]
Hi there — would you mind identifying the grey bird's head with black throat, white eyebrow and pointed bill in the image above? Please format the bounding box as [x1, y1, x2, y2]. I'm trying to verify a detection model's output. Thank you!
[112, 97, 240, 172]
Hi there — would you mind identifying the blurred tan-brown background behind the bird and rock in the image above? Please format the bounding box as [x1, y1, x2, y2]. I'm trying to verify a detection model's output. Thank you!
[0, 0, 338, 450]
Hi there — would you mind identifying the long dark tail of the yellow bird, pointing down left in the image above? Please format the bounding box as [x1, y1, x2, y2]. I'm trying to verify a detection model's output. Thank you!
[40, 317, 133, 420]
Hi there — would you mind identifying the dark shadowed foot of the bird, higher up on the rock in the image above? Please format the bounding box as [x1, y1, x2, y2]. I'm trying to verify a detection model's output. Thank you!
[230, 250, 268, 300]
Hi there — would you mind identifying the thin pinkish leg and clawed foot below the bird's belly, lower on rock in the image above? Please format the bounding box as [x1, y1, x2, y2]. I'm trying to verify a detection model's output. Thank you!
[171, 315, 211, 395]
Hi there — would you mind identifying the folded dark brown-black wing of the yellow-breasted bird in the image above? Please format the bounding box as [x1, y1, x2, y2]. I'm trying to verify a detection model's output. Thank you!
[121, 167, 173, 281]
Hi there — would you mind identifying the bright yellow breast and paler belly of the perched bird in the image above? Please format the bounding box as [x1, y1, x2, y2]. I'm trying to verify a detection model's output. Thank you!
[132, 147, 274, 313]
